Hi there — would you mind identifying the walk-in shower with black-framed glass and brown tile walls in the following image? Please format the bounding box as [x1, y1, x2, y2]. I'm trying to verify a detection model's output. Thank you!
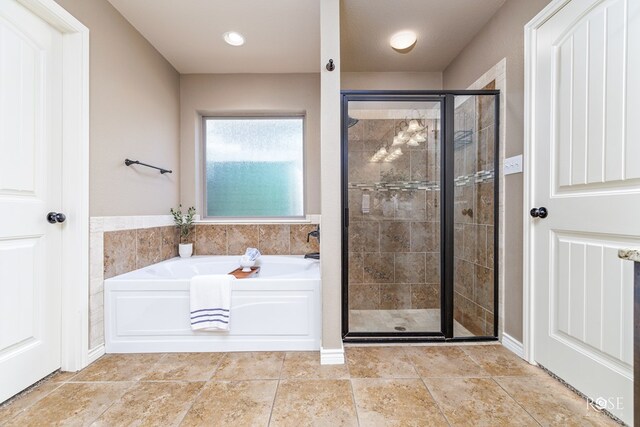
[342, 89, 499, 341]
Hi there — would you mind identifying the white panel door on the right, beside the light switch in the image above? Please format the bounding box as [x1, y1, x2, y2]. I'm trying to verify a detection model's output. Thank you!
[528, 0, 640, 422]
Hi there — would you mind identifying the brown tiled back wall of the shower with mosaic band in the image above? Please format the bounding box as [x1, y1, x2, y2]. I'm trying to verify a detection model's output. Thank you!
[348, 120, 440, 310]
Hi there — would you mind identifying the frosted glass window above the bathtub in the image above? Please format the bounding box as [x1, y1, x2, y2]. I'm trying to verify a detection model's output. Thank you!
[204, 117, 304, 218]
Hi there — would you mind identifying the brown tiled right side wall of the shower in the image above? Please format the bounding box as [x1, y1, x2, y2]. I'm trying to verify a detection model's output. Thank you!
[454, 83, 495, 335]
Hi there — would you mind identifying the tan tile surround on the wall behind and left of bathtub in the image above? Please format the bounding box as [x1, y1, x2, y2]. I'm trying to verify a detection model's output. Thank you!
[89, 216, 319, 349]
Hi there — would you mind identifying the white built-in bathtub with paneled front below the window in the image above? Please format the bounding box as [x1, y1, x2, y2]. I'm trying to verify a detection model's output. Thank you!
[104, 256, 320, 353]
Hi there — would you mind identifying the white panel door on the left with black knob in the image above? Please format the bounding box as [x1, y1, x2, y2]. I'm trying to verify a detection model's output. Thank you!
[0, 0, 64, 402]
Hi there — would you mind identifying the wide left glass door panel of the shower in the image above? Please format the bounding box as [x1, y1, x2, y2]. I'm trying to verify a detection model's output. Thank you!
[343, 96, 442, 336]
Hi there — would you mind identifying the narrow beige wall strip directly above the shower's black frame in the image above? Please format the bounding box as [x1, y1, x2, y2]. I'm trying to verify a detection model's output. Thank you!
[340, 72, 442, 90]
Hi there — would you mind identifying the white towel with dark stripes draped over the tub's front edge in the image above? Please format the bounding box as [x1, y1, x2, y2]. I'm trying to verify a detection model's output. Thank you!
[190, 274, 236, 331]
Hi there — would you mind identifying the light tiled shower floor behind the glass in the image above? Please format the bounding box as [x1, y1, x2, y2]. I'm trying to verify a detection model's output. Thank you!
[349, 308, 473, 337]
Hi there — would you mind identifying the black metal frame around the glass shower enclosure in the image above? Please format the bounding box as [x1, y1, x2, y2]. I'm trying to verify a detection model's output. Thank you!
[340, 90, 500, 343]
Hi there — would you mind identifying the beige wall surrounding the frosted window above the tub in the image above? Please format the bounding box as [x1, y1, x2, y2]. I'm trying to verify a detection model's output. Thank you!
[180, 74, 320, 214]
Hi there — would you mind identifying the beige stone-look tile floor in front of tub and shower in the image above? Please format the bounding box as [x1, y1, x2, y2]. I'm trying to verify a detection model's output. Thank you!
[0, 345, 616, 427]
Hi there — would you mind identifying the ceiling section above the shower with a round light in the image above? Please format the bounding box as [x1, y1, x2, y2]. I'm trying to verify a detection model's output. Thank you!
[340, 0, 505, 71]
